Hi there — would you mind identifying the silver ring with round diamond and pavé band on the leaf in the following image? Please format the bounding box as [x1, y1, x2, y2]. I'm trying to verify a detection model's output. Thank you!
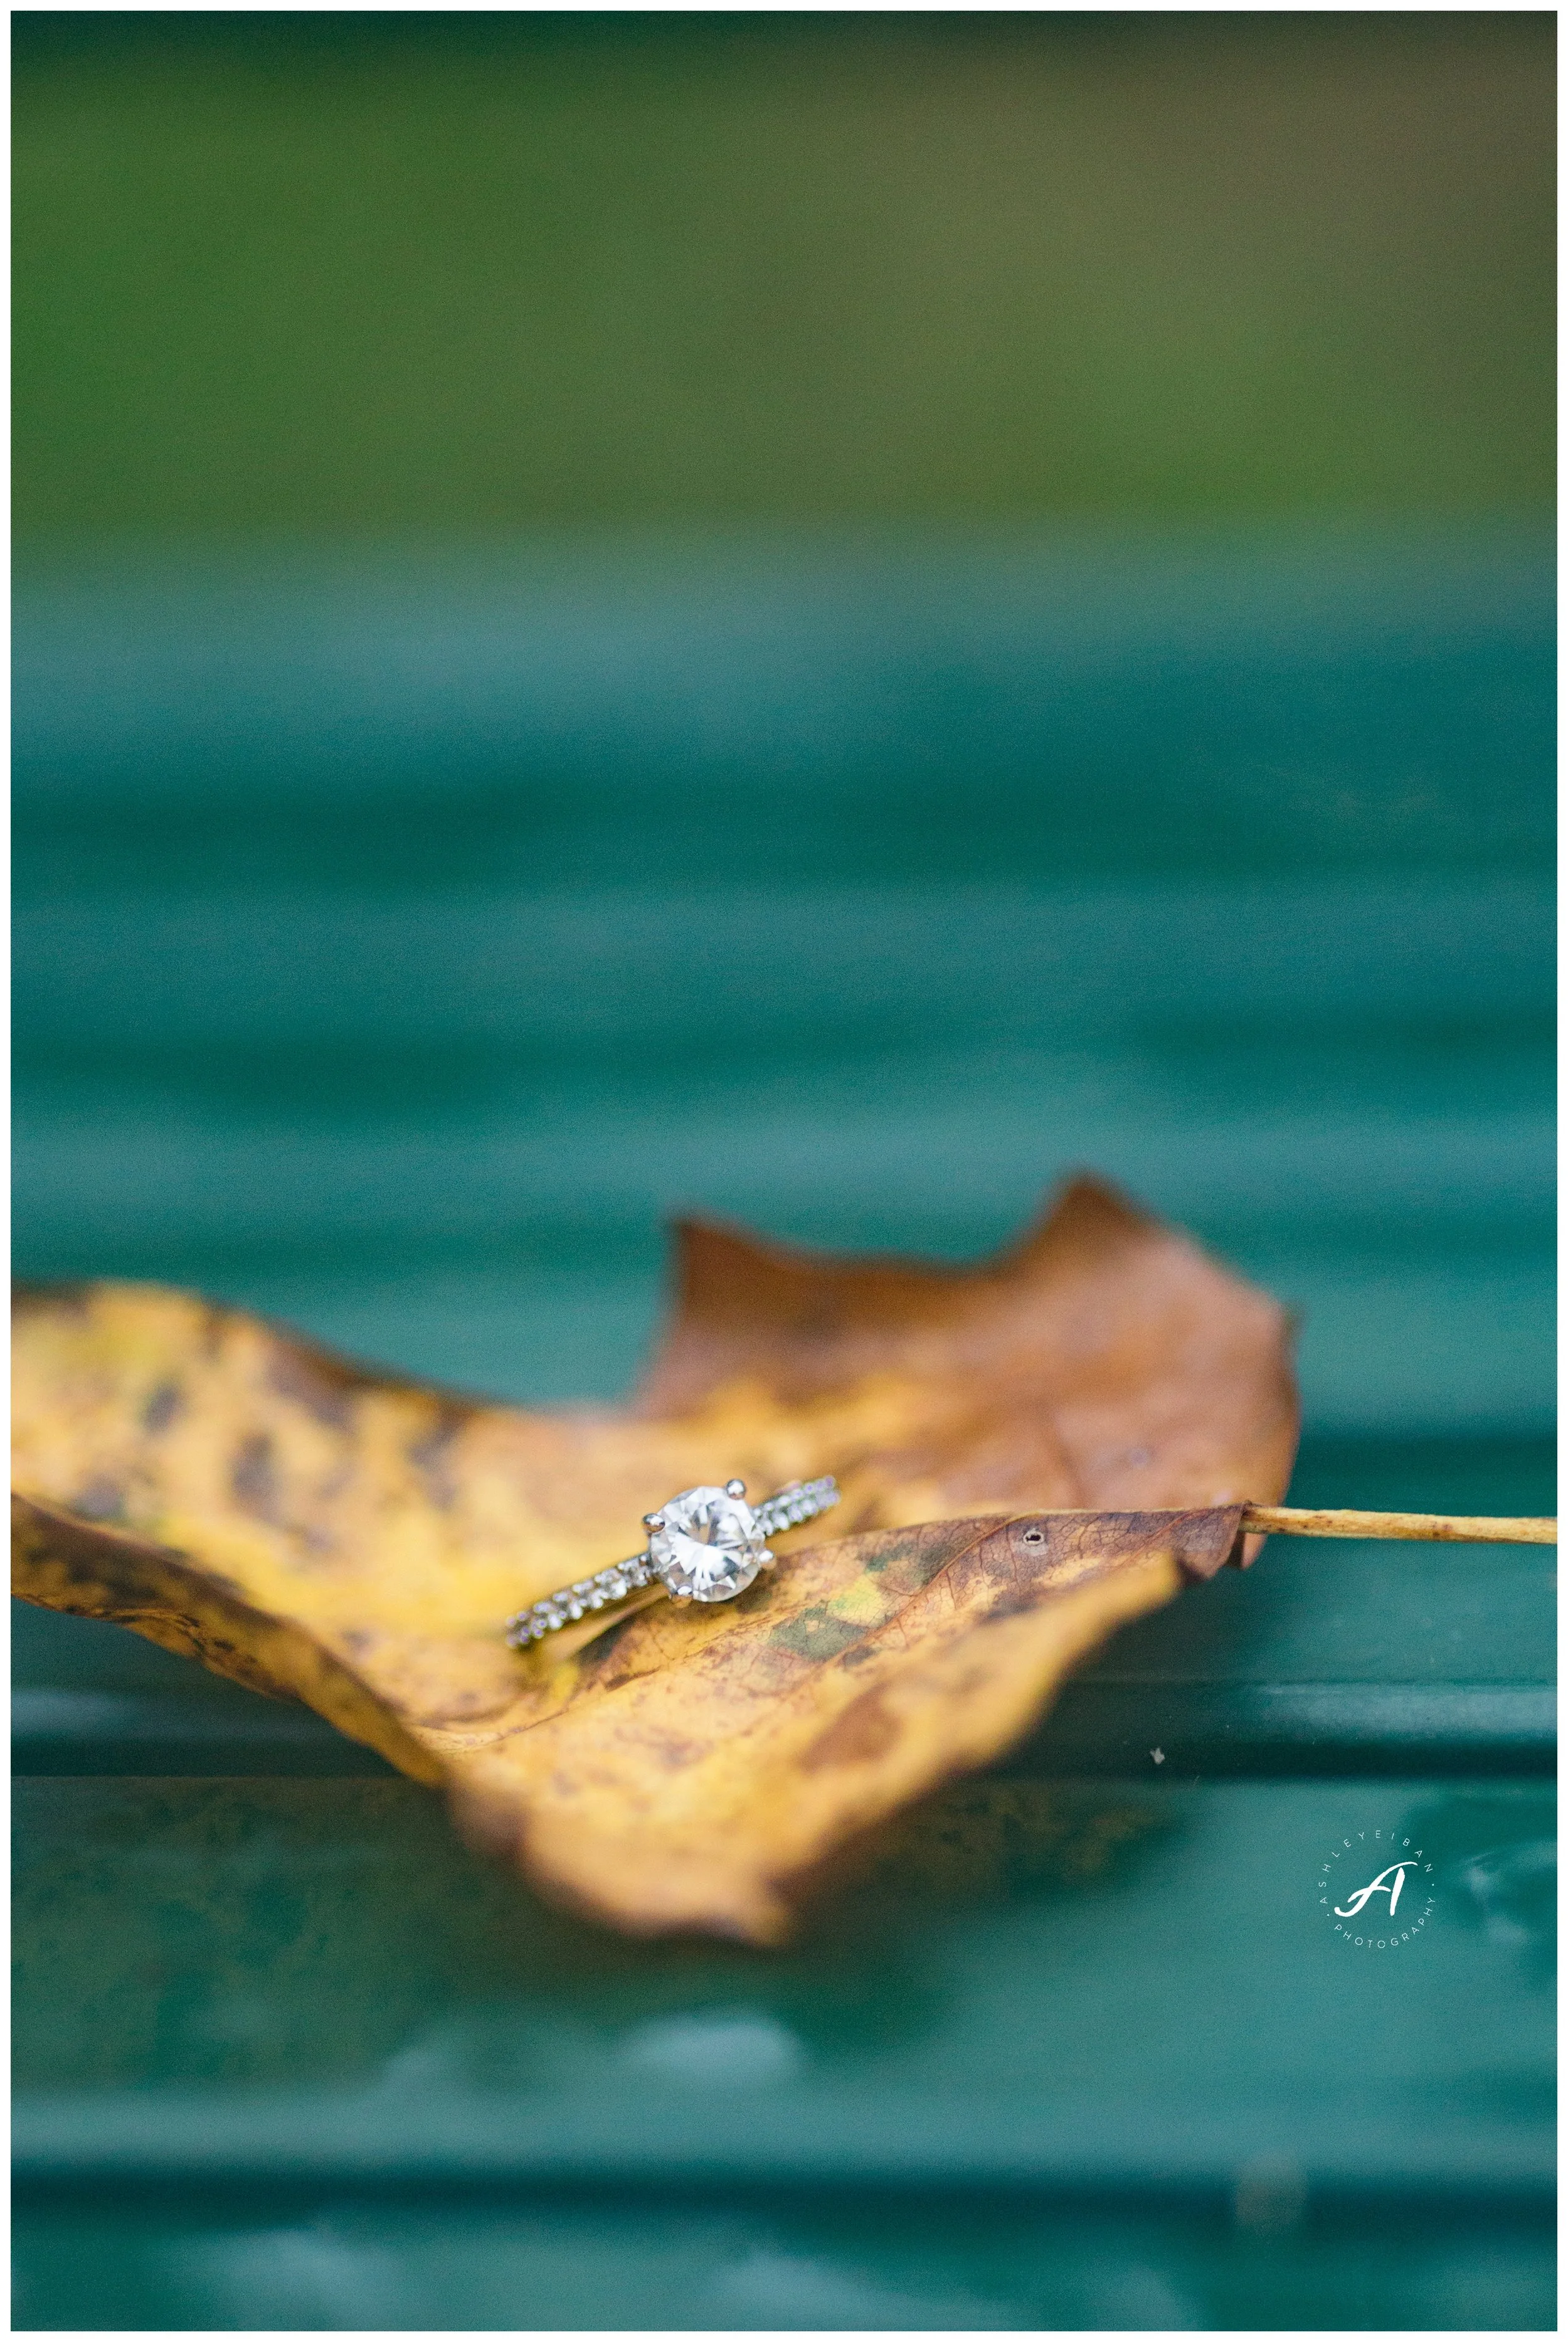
[506, 1476, 838, 1651]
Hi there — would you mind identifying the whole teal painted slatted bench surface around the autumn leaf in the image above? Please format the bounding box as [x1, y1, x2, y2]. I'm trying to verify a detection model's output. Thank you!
[16, 534, 1554, 2328]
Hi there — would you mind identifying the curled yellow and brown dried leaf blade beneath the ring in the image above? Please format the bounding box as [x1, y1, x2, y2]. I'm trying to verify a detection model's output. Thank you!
[14, 1180, 1296, 1942]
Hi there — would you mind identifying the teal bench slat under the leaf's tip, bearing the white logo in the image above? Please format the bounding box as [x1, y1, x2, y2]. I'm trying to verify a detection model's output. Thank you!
[14, 1780, 1554, 2197]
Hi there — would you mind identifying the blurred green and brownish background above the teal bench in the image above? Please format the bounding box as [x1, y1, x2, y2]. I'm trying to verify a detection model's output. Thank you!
[14, 12, 1554, 531]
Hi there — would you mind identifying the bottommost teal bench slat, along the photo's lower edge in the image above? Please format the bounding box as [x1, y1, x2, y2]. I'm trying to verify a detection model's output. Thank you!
[14, 2176, 1554, 2333]
